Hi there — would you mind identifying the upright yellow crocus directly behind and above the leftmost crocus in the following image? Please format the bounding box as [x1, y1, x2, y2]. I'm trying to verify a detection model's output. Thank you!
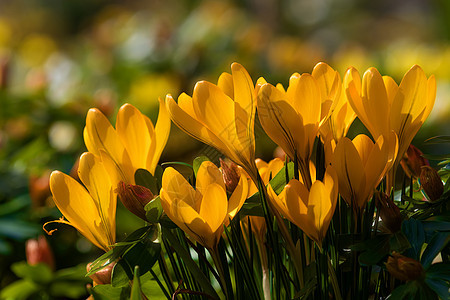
[84, 99, 170, 186]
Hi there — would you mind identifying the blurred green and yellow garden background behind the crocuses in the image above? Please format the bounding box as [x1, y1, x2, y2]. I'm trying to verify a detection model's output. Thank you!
[0, 0, 450, 298]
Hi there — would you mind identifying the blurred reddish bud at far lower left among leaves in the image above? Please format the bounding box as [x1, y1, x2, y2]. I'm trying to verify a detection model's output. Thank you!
[25, 235, 55, 270]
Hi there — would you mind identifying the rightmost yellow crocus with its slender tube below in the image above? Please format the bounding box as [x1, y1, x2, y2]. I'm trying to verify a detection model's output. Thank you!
[345, 65, 436, 190]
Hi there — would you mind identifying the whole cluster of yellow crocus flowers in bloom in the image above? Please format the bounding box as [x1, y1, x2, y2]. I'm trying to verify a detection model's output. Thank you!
[44, 63, 436, 251]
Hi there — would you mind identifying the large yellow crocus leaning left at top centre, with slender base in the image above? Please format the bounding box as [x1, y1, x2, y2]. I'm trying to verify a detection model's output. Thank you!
[166, 63, 257, 181]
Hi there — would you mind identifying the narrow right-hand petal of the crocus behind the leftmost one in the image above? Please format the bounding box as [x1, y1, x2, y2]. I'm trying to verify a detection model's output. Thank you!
[147, 98, 172, 175]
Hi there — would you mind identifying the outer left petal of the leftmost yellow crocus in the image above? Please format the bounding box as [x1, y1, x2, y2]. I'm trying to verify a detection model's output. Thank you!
[50, 171, 109, 251]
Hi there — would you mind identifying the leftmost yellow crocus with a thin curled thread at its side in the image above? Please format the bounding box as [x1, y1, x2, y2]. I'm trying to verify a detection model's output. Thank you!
[44, 152, 117, 251]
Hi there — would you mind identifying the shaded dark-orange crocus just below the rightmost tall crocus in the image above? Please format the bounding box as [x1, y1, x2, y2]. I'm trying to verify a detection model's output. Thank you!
[331, 133, 396, 209]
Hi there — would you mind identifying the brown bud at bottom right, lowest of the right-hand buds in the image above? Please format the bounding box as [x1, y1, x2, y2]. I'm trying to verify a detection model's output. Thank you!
[385, 251, 425, 281]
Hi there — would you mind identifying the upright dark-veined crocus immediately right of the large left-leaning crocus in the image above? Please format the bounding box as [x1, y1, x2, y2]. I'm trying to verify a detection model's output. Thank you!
[257, 69, 322, 188]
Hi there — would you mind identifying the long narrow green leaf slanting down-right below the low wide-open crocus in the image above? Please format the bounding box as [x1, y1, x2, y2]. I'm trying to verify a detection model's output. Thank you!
[162, 227, 220, 299]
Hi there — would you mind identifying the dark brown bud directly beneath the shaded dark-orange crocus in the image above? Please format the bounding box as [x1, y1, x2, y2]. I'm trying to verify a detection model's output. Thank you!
[375, 192, 402, 233]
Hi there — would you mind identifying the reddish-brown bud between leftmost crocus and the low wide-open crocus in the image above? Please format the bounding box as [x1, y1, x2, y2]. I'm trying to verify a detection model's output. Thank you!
[116, 181, 154, 221]
